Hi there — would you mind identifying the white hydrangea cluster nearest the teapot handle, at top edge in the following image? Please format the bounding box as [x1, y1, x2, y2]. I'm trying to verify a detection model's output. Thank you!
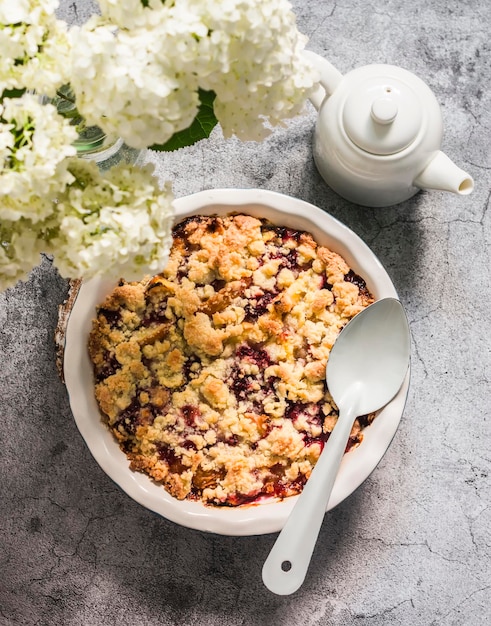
[186, 0, 319, 140]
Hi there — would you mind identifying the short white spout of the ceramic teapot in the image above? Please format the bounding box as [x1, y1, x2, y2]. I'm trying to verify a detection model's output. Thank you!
[413, 150, 474, 196]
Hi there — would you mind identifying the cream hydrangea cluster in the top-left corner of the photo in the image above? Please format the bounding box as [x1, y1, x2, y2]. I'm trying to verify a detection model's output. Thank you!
[0, 0, 70, 96]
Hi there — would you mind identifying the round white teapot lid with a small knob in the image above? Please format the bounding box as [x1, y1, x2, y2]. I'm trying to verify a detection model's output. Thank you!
[343, 72, 423, 155]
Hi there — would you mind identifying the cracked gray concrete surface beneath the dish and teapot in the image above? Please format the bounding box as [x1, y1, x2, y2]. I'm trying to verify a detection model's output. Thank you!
[0, 0, 491, 626]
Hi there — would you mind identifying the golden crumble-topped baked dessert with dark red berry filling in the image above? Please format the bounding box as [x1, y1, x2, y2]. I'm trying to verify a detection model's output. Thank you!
[88, 214, 374, 506]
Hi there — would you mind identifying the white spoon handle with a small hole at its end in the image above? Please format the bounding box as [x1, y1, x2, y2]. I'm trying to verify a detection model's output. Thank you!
[262, 405, 356, 595]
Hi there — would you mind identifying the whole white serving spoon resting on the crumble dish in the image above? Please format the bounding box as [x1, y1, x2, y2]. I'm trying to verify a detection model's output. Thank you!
[263, 298, 410, 595]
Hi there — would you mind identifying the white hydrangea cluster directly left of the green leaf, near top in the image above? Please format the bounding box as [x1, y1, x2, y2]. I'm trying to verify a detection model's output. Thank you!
[71, 17, 199, 148]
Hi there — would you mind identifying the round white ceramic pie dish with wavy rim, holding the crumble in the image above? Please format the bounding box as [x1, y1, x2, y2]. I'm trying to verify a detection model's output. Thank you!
[63, 189, 409, 535]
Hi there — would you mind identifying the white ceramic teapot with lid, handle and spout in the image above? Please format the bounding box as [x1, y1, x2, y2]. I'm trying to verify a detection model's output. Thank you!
[305, 51, 474, 207]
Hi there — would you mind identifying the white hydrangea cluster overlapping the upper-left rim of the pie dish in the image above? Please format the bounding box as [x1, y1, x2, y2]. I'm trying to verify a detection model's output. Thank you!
[49, 159, 174, 280]
